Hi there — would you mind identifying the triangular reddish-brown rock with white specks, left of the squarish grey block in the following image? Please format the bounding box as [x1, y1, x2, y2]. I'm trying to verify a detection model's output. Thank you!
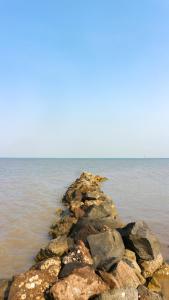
[62, 241, 93, 265]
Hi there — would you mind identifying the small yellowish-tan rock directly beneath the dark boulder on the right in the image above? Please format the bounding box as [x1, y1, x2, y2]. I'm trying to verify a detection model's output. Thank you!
[140, 254, 163, 278]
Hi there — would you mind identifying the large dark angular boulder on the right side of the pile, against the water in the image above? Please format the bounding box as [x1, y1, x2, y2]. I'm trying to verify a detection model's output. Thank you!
[119, 221, 160, 260]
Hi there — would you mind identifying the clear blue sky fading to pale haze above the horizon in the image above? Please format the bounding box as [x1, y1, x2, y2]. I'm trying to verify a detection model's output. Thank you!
[0, 0, 169, 157]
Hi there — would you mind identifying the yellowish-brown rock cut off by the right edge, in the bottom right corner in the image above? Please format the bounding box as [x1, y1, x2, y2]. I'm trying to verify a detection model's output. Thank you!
[148, 264, 169, 300]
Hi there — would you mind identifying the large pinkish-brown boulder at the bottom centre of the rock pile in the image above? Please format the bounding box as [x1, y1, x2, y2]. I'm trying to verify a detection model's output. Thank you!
[50, 267, 107, 300]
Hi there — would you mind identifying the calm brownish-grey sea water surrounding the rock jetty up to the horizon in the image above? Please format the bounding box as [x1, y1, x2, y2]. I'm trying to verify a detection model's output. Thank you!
[0, 159, 169, 278]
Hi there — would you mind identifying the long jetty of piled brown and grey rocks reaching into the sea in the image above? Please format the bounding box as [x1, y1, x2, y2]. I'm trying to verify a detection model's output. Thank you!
[0, 173, 169, 300]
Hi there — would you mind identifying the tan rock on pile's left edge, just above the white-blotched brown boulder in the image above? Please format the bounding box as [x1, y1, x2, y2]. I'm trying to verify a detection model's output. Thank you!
[36, 235, 71, 261]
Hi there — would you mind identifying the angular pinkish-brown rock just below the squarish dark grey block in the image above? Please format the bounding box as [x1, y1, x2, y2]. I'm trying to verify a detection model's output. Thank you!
[100, 261, 145, 289]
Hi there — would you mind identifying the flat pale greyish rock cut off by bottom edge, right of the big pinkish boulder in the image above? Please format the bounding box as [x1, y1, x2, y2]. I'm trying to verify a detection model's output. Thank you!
[97, 288, 138, 300]
